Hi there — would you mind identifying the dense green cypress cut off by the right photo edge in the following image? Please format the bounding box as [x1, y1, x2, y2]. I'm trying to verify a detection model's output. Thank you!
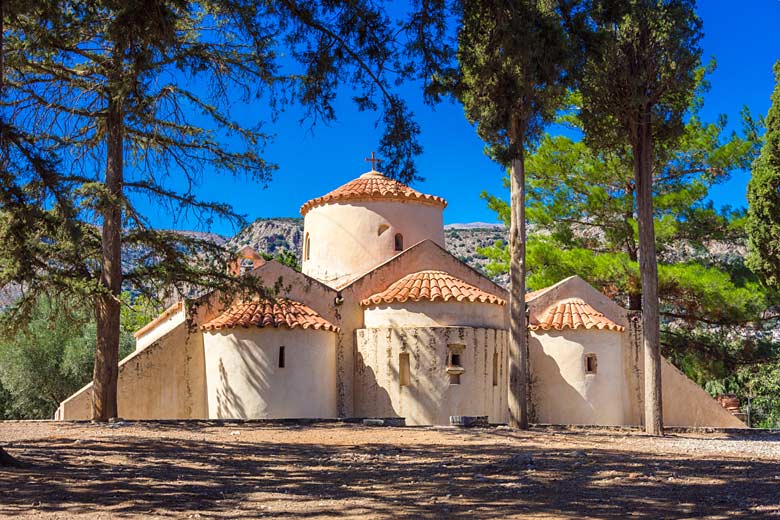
[747, 61, 780, 288]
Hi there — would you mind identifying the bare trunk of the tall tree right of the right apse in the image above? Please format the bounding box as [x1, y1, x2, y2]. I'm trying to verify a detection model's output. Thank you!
[633, 108, 663, 435]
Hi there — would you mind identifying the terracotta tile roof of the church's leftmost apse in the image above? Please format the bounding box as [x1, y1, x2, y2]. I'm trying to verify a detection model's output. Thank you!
[201, 298, 339, 332]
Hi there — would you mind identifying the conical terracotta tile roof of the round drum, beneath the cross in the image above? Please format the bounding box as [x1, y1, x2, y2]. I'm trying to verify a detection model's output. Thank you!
[301, 171, 447, 215]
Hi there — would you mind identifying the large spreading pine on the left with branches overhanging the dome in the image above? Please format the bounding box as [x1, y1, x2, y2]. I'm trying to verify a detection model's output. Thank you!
[0, 0, 436, 420]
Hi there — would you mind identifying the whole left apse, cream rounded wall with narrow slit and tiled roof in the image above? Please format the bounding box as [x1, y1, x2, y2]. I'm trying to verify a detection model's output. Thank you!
[203, 299, 339, 419]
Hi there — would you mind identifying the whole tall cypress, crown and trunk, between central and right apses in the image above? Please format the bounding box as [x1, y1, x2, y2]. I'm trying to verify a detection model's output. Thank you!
[432, 0, 579, 428]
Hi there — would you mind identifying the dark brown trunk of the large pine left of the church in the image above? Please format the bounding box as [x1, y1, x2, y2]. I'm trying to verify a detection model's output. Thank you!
[92, 96, 124, 421]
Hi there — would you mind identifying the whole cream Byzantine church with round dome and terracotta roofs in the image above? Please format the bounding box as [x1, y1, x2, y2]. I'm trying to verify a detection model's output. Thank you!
[56, 163, 745, 428]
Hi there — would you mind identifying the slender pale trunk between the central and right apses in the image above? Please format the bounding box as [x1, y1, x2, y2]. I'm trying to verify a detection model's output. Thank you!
[508, 144, 528, 429]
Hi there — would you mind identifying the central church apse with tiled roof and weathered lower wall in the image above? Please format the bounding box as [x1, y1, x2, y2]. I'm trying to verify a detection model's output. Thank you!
[355, 271, 507, 425]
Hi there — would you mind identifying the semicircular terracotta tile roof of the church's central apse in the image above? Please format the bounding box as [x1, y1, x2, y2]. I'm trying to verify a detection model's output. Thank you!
[361, 271, 506, 306]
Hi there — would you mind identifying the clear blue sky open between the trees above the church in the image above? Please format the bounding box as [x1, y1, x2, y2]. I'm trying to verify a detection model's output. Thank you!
[140, 0, 780, 235]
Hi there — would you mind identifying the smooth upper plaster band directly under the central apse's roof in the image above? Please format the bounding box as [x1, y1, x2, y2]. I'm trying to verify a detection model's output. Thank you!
[365, 300, 506, 329]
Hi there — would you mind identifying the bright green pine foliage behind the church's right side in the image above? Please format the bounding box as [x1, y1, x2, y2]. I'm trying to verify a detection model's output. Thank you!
[478, 88, 780, 384]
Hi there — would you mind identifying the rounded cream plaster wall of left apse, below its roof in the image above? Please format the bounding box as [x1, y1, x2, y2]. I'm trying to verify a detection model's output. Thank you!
[203, 328, 337, 419]
